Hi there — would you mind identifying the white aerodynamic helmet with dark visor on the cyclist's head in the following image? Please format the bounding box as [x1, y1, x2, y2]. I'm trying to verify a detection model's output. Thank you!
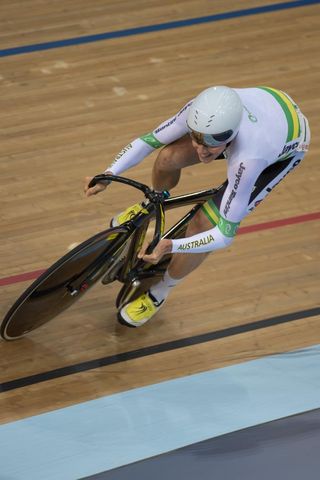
[187, 86, 243, 147]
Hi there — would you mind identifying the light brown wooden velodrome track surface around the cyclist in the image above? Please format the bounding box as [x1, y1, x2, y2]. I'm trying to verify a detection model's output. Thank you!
[0, 0, 320, 423]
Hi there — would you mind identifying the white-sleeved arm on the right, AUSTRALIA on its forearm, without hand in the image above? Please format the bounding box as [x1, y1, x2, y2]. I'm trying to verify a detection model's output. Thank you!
[172, 161, 267, 253]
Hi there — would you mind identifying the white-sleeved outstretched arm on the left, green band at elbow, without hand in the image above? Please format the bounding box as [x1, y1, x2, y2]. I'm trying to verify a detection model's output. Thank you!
[105, 102, 192, 175]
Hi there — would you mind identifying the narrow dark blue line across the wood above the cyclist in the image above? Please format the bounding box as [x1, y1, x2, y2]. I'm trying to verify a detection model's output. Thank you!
[0, 0, 320, 57]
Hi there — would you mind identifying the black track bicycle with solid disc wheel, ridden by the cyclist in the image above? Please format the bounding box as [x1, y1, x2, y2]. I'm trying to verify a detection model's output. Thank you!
[0, 174, 222, 340]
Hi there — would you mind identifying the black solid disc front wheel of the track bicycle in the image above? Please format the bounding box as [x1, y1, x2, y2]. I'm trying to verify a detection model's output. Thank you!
[0, 226, 130, 340]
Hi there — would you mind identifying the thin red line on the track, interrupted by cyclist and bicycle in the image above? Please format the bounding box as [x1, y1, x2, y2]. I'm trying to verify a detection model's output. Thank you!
[0, 212, 320, 287]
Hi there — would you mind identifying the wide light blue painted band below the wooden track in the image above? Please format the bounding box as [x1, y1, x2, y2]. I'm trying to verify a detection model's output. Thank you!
[0, 345, 320, 480]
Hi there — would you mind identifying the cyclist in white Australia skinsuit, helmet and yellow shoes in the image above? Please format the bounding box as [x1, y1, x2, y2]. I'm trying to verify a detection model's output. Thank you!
[85, 86, 310, 327]
